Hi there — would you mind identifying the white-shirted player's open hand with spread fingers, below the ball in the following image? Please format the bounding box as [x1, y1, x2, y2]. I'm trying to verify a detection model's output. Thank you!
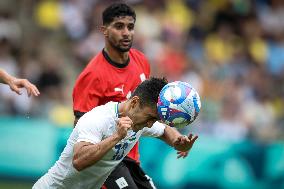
[174, 134, 198, 153]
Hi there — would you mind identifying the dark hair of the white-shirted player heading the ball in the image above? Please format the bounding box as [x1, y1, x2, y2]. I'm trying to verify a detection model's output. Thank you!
[131, 77, 168, 107]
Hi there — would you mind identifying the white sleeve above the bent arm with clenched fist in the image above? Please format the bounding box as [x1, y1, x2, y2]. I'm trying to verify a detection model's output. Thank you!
[76, 109, 107, 144]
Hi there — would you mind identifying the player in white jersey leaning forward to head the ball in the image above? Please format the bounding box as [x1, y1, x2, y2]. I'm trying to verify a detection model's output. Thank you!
[33, 78, 196, 189]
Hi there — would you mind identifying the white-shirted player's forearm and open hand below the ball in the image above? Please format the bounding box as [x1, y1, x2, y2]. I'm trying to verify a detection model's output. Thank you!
[161, 126, 198, 158]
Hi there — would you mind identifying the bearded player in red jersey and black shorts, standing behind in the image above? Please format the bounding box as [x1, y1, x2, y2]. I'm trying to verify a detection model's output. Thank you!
[73, 4, 197, 189]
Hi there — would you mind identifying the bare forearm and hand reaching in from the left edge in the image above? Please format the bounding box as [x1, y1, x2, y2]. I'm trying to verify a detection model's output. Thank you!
[0, 69, 40, 96]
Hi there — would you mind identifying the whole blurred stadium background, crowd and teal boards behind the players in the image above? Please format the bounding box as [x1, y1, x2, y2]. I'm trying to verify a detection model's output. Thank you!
[0, 0, 284, 189]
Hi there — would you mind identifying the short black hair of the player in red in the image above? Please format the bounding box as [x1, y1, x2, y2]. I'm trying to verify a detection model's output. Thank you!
[102, 3, 136, 25]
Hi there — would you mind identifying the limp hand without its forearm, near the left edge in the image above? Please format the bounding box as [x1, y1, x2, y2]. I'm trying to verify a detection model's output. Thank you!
[8, 78, 40, 96]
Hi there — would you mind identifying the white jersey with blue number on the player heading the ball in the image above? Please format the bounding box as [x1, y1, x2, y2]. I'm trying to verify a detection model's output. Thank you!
[33, 102, 165, 189]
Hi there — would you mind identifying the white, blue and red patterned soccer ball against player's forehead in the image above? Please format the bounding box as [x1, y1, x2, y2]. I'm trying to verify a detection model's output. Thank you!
[157, 81, 201, 128]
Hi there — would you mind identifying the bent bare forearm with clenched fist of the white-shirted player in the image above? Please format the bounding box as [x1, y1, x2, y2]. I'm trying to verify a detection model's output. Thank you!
[72, 117, 132, 171]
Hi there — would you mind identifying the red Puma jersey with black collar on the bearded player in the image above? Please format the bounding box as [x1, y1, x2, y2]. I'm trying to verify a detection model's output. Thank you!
[73, 49, 150, 161]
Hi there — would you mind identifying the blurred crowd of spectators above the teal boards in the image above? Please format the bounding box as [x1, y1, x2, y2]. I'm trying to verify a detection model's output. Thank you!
[0, 0, 284, 142]
